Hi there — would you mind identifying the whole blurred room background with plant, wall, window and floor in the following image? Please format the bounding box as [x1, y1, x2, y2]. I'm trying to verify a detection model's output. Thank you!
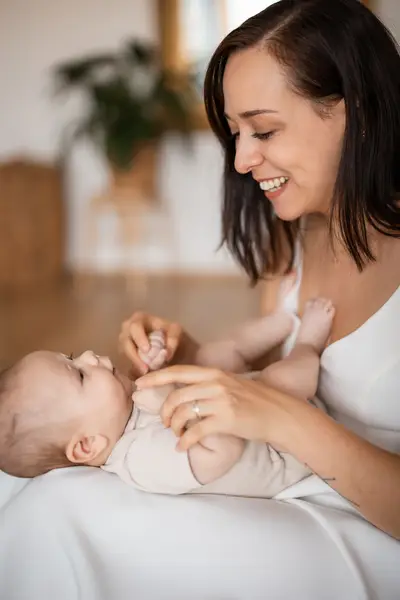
[0, 0, 400, 368]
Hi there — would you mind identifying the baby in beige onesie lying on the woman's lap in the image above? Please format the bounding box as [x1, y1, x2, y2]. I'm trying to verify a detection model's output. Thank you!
[0, 299, 334, 497]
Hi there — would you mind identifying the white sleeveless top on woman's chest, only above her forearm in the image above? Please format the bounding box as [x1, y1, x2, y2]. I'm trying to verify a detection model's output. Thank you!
[279, 241, 400, 498]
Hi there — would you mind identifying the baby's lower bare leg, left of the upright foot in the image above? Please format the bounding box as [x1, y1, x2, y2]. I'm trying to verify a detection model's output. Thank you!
[196, 311, 293, 373]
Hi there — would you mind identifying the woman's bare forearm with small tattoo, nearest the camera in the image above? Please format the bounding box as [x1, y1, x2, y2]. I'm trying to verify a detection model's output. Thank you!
[282, 398, 400, 539]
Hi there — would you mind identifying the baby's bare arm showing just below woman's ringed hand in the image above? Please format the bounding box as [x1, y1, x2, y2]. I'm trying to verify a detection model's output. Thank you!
[188, 434, 245, 485]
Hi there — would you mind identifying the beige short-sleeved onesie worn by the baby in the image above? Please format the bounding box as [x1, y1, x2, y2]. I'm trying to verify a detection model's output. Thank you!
[102, 386, 310, 498]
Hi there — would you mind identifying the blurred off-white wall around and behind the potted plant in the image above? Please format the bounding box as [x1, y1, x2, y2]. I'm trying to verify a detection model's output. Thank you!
[0, 0, 236, 272]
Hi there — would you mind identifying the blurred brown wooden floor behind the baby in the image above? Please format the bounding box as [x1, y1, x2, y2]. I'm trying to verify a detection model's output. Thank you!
[0, 276, 260, 368]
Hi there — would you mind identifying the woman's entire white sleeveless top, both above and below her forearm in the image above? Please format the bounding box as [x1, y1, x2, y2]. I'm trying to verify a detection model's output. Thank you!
[275, 241, 400, 600]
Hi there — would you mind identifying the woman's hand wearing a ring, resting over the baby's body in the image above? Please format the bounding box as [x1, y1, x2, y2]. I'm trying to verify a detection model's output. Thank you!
[136, 366, 287, 451]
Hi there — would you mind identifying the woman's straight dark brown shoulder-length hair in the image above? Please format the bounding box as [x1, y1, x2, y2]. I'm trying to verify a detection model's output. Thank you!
[204, 0, 400, 283]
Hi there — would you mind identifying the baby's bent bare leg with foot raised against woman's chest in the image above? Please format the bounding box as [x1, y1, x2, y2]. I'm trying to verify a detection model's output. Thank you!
[261, 298, 335, 400]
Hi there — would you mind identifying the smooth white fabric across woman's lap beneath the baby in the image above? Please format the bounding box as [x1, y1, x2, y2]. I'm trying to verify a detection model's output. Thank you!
[0, 467, 397, 600]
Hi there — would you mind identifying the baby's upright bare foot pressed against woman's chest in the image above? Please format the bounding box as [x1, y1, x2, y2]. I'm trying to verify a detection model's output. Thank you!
[296, 298, 335, 354]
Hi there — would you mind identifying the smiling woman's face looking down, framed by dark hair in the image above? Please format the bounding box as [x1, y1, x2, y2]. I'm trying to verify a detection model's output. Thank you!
[223, 48, 346, 221]
